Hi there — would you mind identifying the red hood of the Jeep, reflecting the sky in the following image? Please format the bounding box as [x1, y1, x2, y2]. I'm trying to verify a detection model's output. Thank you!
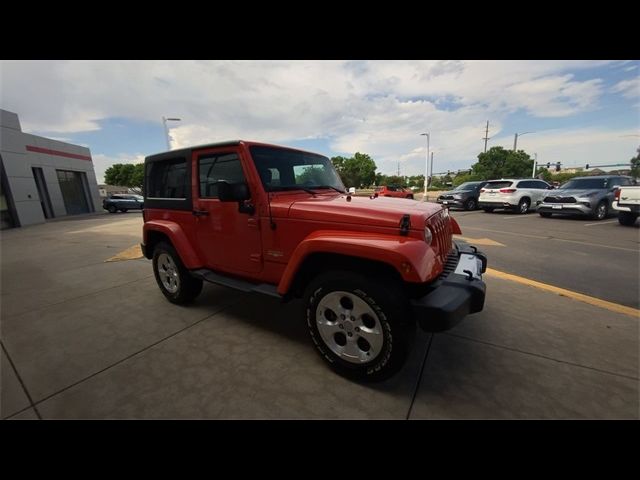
[272, 195, 443, 230]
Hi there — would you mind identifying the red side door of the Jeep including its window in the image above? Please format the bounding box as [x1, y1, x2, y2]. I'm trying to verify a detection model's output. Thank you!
[192, 147, 262, 273]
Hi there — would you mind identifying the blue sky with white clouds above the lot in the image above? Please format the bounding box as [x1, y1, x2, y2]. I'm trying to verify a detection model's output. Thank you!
[0, 60, 640, 182]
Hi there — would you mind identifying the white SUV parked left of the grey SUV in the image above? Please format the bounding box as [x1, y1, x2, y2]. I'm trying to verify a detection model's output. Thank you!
[478, 178, 553, 214]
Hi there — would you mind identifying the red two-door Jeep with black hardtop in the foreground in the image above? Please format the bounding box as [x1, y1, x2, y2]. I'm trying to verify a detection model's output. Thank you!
[141, 141, 487, 380]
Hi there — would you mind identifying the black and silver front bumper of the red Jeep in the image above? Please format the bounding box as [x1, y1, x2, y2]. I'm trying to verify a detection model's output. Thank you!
[411, 245, 487, 332]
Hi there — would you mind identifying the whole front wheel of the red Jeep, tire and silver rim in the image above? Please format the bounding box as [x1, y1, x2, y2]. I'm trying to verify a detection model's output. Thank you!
[304, 271, 416, 381]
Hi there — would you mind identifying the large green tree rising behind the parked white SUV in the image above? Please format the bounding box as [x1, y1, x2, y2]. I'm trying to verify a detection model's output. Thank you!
[471, 147, 533, 180]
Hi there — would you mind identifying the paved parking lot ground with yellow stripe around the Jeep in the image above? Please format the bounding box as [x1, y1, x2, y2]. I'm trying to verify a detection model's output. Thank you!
[0, 211, 640, 419]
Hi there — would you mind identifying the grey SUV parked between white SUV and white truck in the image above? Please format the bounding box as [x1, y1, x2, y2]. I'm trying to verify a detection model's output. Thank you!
[538, 175, 633, 220]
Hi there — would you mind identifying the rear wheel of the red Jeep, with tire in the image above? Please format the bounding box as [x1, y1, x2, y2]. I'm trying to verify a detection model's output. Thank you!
[152, 242, 202, 305]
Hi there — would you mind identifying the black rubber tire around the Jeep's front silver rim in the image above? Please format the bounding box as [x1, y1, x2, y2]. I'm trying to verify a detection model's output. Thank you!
[304, 271, 416, 382]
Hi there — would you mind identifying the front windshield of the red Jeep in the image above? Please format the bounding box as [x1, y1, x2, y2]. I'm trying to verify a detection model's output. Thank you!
[249, 146, 344, 193]
